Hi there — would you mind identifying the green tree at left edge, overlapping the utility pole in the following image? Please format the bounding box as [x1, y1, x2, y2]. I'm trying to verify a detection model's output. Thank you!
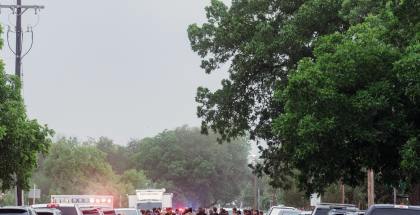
[0, 30, 52, 190]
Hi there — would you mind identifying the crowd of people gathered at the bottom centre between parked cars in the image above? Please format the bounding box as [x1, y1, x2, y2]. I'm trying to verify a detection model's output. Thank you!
[141, 207, 264, 215]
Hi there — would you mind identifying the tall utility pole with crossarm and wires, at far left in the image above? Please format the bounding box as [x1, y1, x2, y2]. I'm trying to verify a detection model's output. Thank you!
[0, 0, 44, 206]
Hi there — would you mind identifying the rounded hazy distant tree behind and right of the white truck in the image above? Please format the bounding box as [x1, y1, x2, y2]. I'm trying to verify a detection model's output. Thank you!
[132, 127, 249, 206]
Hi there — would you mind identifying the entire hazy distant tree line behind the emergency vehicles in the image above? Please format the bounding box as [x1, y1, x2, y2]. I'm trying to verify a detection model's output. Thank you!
[0, 126, 251, 207]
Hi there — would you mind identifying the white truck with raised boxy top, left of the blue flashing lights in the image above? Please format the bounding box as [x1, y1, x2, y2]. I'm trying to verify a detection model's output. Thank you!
[128, 189, 173, 210]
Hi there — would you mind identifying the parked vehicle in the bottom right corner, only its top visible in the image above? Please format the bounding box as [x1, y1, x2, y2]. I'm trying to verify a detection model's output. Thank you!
[365, 204, 420, 215]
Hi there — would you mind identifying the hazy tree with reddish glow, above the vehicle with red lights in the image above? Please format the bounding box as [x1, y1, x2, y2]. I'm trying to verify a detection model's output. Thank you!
[43, 138, 118, 194]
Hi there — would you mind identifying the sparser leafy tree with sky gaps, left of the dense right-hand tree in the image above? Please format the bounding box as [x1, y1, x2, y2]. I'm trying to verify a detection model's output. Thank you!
[188, 0, 384, 145]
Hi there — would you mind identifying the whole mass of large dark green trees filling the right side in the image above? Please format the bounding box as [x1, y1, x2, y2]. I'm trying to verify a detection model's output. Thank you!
[188, 0, 419, 199]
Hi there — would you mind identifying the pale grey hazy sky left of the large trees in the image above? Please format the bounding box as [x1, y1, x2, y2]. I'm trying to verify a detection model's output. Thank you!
[0, 0, 230, 144]
